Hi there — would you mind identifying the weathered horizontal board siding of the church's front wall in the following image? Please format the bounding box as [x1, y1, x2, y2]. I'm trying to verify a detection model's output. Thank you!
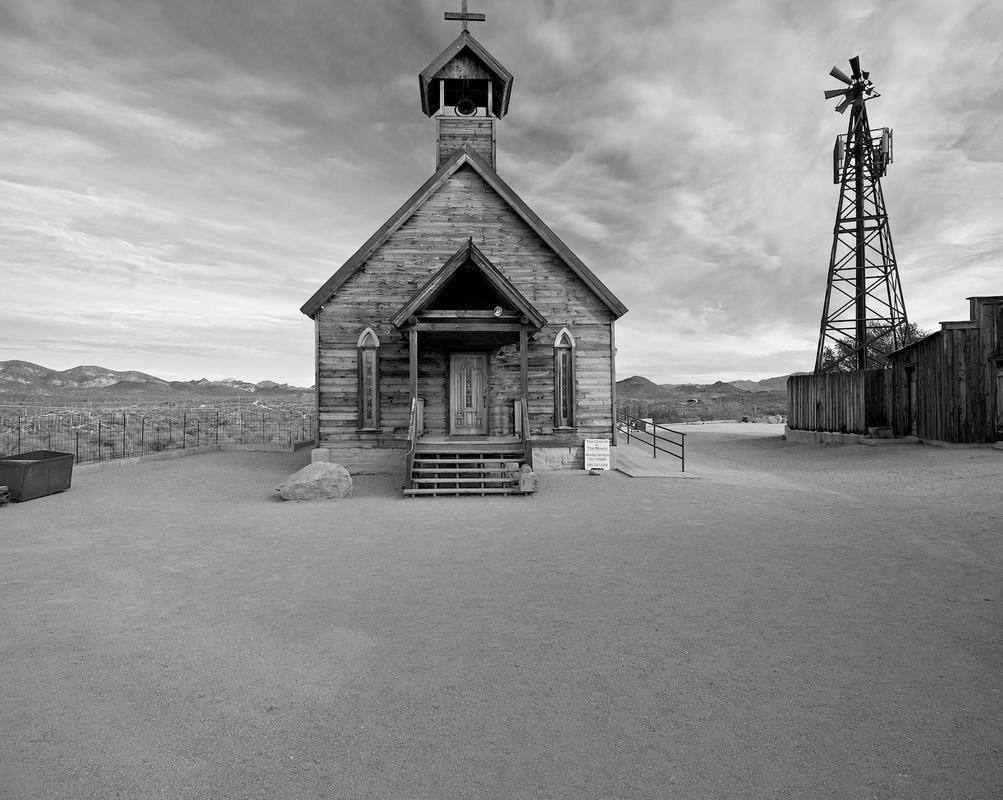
[316, 165, 614, 451]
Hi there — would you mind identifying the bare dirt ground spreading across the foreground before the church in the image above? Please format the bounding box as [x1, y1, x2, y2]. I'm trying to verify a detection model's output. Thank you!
[0, 424, 1003, 800]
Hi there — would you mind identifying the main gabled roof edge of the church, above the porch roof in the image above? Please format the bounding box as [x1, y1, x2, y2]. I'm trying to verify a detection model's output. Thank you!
[300, 145, 627, 317]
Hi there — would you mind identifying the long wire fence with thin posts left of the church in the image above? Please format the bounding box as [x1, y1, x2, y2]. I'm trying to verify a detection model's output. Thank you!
[0, 409, 317, 464]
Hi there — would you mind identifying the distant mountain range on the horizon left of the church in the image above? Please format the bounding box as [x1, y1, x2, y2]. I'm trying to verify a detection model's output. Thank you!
[0, 361, 312, 397]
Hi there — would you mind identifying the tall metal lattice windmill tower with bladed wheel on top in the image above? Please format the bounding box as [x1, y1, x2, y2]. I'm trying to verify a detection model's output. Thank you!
[814, 56, 909, 372]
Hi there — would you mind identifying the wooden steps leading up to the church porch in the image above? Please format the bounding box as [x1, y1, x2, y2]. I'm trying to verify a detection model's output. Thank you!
[404, 441, 526, 497]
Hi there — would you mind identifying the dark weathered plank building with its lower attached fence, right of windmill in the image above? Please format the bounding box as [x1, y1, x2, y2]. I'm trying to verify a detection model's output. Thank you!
[787, 296, 1003, 444]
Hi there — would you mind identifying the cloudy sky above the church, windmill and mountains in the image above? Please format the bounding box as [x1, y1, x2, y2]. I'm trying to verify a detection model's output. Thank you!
[0, 0, 1003, 386]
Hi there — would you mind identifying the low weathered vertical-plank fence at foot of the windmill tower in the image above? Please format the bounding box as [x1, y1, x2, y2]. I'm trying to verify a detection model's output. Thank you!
[787, 370, 894, 433]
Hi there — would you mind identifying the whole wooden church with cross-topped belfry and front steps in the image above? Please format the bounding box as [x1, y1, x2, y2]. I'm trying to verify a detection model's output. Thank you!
[301, 6, 626, 494]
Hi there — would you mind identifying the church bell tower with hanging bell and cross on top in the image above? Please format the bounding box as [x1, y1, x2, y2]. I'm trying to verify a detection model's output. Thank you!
[418, 0, 513, 169]
